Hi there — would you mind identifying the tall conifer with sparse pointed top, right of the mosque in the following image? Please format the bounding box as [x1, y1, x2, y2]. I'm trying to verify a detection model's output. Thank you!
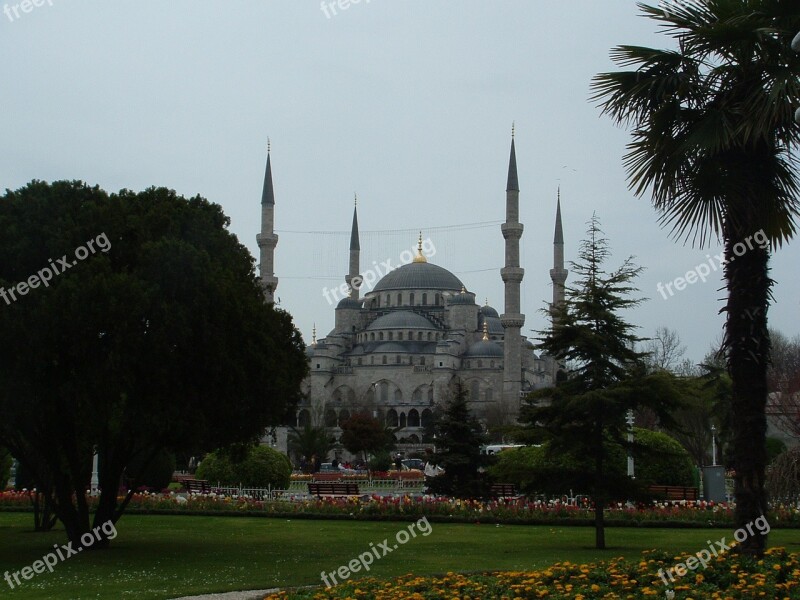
[520, 216, 676, 549]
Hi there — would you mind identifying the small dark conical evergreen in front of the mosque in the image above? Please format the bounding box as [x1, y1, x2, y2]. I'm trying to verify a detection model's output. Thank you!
[428, 383, 488, 498]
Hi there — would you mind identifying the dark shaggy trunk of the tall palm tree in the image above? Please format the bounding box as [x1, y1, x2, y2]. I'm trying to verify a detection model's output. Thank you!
[724, 232, 772, 556]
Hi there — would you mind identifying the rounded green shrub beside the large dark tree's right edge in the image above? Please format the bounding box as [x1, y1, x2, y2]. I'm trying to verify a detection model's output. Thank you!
[196, 446, 292, 489]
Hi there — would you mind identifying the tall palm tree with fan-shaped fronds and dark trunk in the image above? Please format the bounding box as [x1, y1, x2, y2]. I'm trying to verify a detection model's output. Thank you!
[593, 0, 800, 555]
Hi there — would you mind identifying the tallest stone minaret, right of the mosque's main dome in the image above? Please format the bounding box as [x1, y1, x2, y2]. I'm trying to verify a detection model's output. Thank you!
[500, 126, 525, 417]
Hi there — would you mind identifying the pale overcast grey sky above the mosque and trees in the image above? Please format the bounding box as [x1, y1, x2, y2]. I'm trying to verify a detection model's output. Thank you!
[0, 0, 800, 360]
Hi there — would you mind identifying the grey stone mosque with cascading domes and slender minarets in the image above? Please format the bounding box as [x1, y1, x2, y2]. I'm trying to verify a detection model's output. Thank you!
[257, 135, 567, 448]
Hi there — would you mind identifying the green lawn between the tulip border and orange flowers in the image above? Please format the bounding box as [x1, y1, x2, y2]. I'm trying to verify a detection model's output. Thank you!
[0, 513, 800, 600]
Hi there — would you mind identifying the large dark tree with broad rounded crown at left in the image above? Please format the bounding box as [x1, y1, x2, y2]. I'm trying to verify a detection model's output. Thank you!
[0, 181, 307, 548]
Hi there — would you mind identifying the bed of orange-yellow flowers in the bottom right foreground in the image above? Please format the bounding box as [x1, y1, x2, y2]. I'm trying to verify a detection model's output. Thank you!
[265, 548, 800, 600]
